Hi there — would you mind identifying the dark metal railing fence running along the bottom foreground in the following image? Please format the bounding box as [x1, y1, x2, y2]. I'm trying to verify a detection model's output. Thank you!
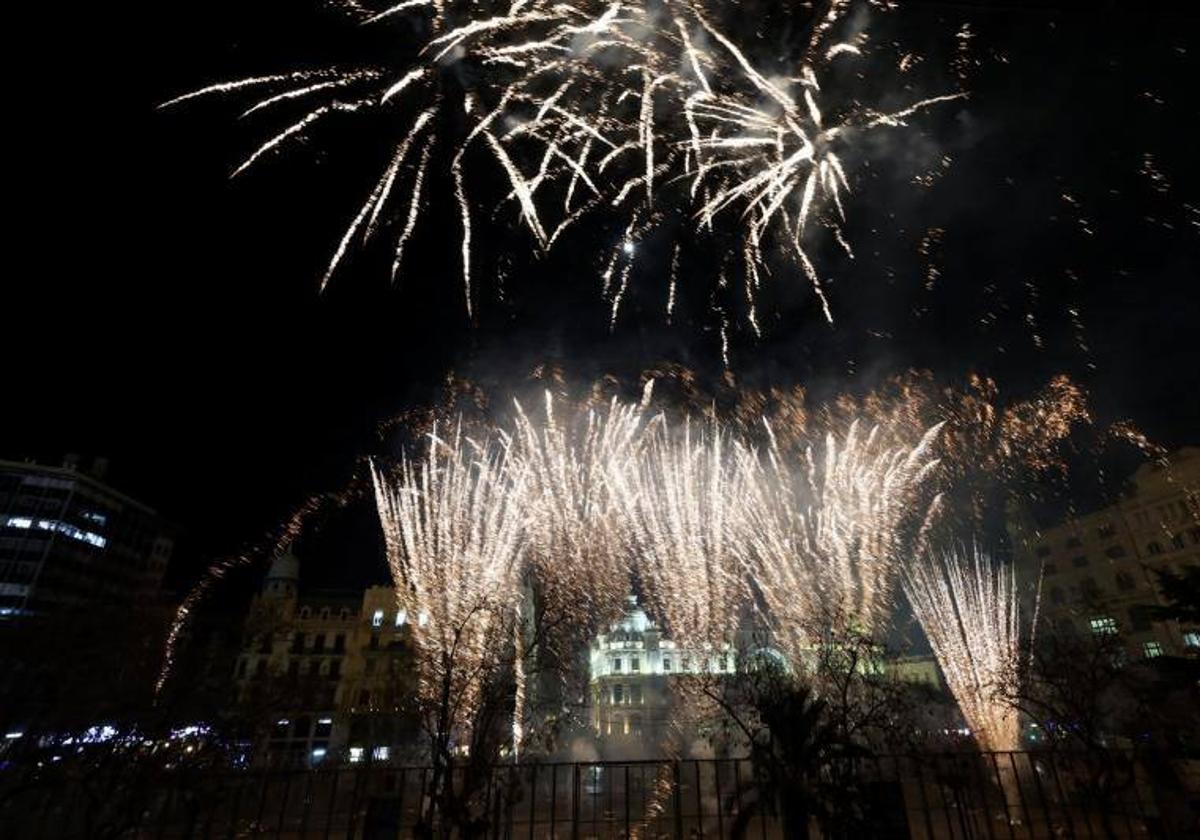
[0, 752, 1165, 840]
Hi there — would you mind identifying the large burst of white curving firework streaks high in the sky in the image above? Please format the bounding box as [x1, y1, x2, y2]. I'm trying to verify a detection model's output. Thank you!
[164, 0, 961, 334]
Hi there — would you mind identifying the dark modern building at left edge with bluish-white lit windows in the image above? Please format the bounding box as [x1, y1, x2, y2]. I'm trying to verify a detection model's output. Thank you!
[0, 458, 175, 618]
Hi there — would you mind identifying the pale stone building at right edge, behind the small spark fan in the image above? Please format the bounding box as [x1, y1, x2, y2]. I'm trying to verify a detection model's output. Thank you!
[1009, 446, 1200, 659]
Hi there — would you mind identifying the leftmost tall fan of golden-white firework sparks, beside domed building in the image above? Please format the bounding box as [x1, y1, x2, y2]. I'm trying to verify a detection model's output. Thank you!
[372, 426, 524, 739]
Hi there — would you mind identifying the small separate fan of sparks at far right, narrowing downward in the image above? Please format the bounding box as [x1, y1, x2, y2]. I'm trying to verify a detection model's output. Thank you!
[904, 546, 1020, 751]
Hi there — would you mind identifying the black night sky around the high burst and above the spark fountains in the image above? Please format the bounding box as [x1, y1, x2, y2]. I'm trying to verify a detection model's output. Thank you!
[0, 0, 1200, 588]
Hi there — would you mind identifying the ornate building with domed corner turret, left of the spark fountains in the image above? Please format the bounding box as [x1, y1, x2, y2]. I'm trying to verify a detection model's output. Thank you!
[234, 552, 415, 766]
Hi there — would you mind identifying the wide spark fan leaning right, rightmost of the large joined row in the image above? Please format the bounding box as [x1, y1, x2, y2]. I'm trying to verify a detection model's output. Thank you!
[743, 420, 942, 648]
